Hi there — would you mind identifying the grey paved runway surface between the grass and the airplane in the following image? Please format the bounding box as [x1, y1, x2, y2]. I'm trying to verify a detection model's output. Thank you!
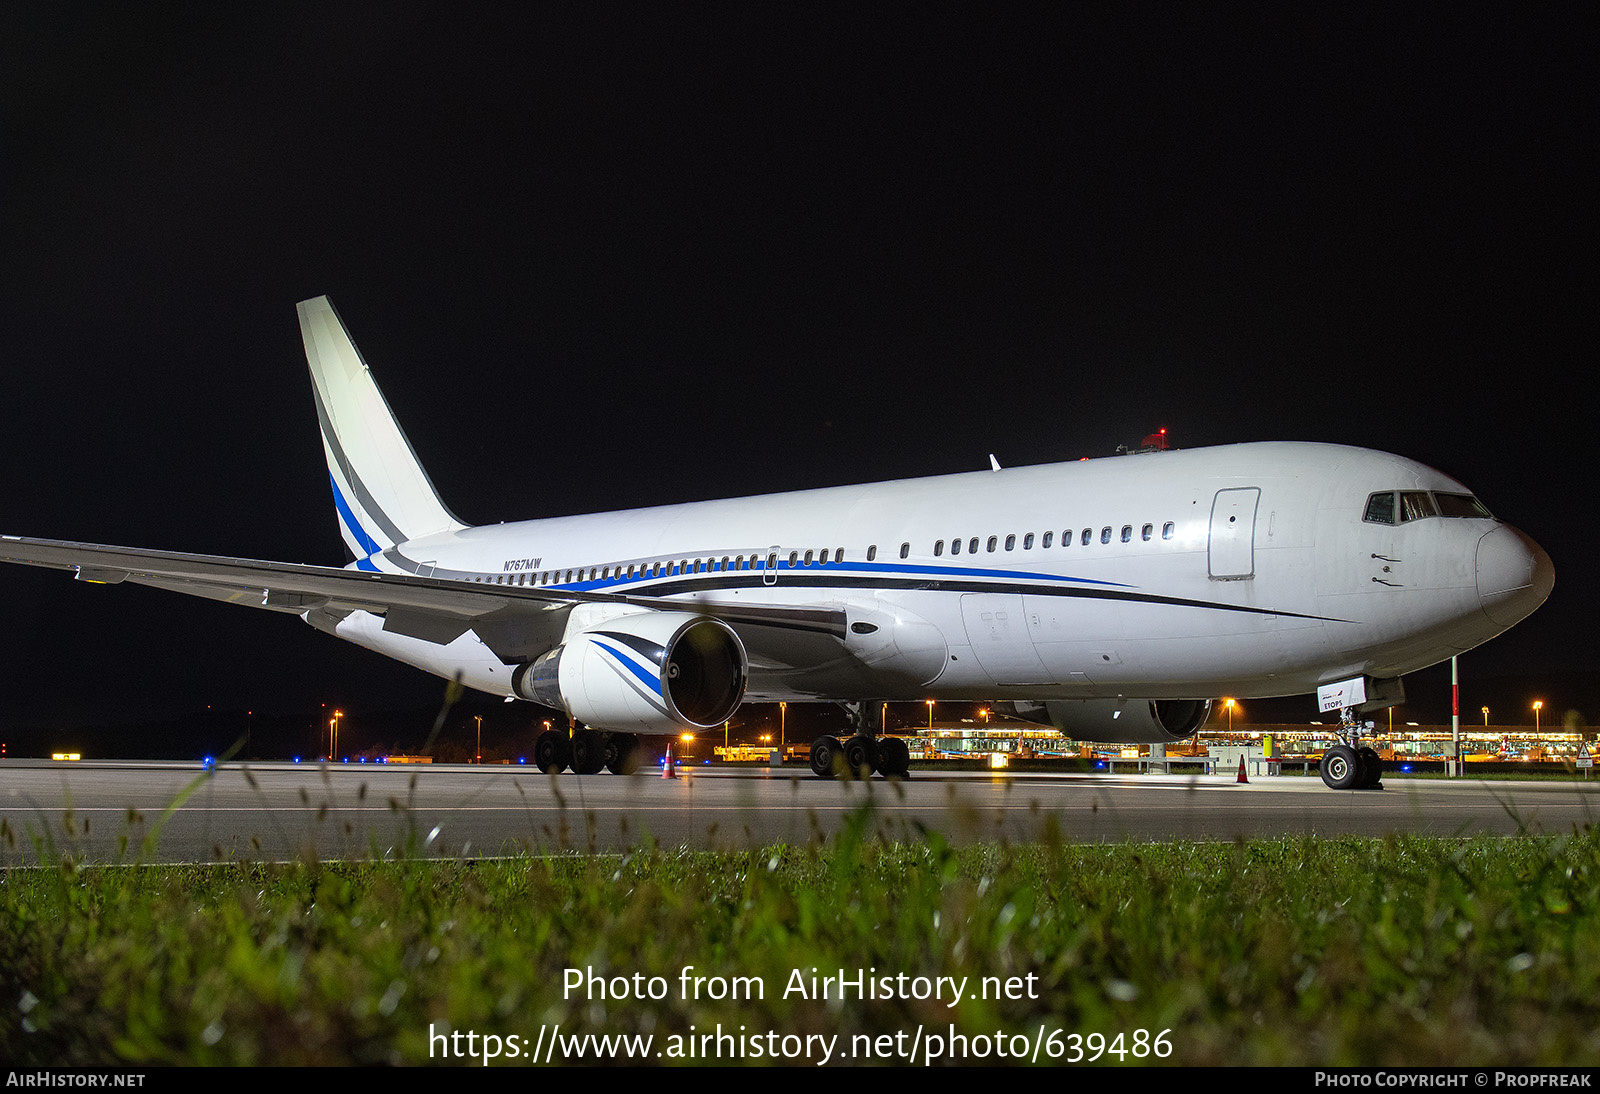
[0, 760, 1600, 865]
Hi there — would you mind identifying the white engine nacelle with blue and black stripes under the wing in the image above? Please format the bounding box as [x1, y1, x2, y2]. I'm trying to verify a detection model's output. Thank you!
[512, 611, 749, 734]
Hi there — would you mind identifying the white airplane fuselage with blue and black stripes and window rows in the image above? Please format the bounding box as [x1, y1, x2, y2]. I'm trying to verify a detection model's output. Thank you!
[328, 443, 1554, 701]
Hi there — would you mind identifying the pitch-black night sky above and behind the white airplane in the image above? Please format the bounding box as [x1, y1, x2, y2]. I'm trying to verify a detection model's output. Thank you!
[0, 3, 1600, 738]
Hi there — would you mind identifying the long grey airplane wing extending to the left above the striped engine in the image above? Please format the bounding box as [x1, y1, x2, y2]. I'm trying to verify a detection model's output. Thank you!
[0, 536, 845, 664]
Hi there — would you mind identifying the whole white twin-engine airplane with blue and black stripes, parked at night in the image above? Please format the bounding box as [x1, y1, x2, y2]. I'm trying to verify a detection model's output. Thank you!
[0, 296, 1555, 789]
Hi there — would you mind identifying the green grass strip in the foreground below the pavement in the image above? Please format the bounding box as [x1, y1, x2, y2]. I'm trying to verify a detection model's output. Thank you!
[0, 813, 1600, 1065]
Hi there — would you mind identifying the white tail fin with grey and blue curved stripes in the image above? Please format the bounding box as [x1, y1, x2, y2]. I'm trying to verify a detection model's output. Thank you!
[298, 296, 466, 560]
